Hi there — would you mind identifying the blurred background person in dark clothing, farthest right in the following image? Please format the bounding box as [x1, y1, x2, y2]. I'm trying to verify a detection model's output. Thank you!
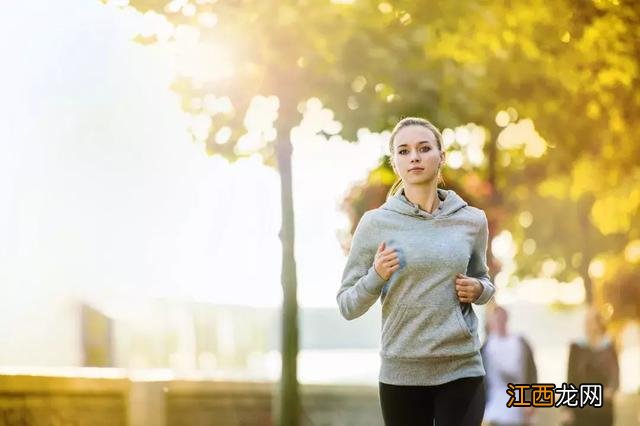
[562, 306, 620, 426]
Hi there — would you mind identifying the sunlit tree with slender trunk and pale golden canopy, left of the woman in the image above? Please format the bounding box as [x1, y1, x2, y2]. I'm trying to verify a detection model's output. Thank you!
[107, 0, 462, 425]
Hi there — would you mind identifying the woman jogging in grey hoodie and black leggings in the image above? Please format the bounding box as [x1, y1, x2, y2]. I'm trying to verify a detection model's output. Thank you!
[337, 117, 495, 426]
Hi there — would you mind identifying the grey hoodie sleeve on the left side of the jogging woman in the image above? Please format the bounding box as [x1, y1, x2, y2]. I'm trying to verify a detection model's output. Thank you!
[336, 212, 386, 320]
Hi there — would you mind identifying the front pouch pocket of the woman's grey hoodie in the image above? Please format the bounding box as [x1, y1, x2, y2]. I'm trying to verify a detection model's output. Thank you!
[380, 303, 476, 358]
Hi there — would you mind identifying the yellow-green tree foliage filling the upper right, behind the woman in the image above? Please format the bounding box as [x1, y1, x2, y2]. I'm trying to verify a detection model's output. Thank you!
[340, 0, 640, 316]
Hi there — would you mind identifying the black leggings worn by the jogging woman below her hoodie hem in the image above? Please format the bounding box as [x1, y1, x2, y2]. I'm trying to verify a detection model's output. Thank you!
[378, 376, 486, 426]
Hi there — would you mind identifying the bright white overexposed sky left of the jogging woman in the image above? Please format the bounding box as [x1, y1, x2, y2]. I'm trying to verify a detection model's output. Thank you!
[0, 0, 382, 319]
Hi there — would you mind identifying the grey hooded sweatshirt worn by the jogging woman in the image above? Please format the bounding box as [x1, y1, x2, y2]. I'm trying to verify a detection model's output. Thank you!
[337, 188, 495, 386]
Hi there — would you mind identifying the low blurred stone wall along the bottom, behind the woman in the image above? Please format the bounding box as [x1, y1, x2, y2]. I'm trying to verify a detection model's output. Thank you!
[0, 369, 640, 426]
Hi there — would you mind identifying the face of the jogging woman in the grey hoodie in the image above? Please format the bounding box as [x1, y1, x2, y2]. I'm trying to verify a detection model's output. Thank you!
[391, 125, 445, 185]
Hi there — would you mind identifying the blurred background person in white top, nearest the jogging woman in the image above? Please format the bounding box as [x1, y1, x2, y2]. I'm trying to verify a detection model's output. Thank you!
[480, 305, 538, 426]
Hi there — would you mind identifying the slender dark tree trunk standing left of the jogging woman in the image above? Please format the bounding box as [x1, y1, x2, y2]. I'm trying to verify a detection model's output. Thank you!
[276, 120, 300, 426]
